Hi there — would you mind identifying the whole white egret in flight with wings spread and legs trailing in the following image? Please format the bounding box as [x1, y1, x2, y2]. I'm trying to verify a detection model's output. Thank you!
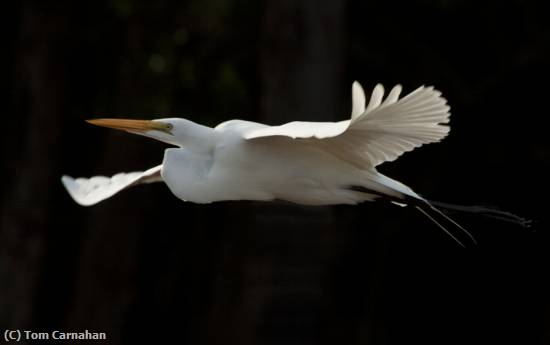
[61, 82, 486, 245]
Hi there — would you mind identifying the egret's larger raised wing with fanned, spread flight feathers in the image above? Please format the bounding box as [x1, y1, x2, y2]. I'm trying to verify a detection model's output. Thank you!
[243, 82, 450, 167]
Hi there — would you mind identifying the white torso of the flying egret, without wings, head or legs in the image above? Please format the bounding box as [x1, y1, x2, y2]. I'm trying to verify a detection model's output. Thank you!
[161, 123, 412, 205]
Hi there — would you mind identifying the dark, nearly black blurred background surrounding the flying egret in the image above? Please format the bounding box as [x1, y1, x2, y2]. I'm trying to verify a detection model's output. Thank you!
[0, 0, 550, 344]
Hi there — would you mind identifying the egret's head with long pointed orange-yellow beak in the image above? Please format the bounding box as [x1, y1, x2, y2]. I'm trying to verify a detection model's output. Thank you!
[86, 118, 209, 146]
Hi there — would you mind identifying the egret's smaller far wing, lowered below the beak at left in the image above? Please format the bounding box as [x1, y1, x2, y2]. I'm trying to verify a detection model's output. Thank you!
[61, 165, 162, 206]
